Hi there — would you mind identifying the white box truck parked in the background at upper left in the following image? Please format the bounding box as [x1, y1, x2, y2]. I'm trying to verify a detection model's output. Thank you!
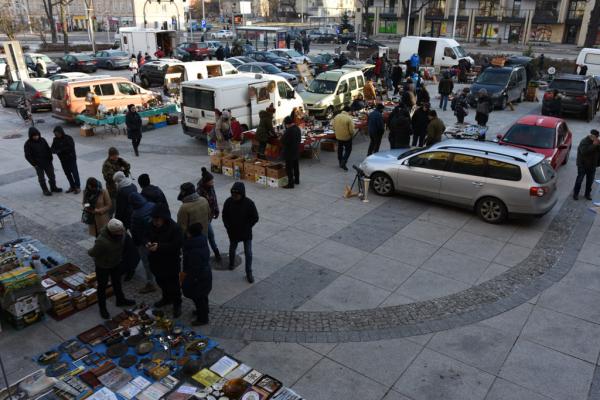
[119, 27, 177, 56]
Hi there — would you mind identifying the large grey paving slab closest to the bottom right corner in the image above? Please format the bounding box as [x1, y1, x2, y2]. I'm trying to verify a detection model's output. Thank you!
[499, 339, 594, 400]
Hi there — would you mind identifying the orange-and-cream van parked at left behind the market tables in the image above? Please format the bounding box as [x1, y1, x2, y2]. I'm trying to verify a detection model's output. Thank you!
[51, 75, 155, 122]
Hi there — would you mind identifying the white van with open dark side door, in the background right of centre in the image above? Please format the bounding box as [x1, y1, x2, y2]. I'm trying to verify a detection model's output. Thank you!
[398, 36, 475, 68]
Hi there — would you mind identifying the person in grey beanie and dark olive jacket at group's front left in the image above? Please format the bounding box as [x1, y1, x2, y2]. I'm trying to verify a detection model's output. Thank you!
[88, 218, 135, 319]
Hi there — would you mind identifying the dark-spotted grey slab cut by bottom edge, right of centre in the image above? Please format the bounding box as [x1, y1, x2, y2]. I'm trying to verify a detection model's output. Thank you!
[394, 349, 494, 400]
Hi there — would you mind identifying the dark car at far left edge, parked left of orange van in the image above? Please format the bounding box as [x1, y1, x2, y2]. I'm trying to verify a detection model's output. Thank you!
[0, 78, 52, 112]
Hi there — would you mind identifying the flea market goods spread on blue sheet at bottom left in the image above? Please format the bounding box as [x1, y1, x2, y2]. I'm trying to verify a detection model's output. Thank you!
[0, 305, 302, 400]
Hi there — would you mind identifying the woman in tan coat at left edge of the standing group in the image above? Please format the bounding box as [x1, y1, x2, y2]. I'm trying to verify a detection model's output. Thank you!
[81, 177, 112, 237]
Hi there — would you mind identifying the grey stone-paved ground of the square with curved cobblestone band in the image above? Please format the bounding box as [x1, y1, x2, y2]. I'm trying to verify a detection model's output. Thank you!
[0, 86, 600, 400]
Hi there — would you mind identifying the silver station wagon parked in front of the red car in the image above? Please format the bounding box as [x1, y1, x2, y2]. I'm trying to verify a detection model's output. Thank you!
[360, 140, 558, 223]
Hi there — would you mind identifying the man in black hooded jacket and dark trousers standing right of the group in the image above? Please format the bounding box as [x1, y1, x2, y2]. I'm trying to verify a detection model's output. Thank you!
[223, 182, 258, 283]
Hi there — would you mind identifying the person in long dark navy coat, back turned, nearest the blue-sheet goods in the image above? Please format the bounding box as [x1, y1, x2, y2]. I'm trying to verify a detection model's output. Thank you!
[181, 223, 212, 326]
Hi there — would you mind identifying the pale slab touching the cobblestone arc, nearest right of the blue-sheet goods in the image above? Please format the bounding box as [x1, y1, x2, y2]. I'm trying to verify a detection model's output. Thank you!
[327, 339, 422, 387]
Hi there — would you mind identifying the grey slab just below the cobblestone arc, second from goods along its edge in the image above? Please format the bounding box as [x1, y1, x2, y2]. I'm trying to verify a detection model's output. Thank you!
[427, 324, 516, 375]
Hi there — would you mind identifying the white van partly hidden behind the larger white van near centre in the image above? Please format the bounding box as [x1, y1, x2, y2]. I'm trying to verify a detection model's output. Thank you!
[165, 60, 238, 90]
